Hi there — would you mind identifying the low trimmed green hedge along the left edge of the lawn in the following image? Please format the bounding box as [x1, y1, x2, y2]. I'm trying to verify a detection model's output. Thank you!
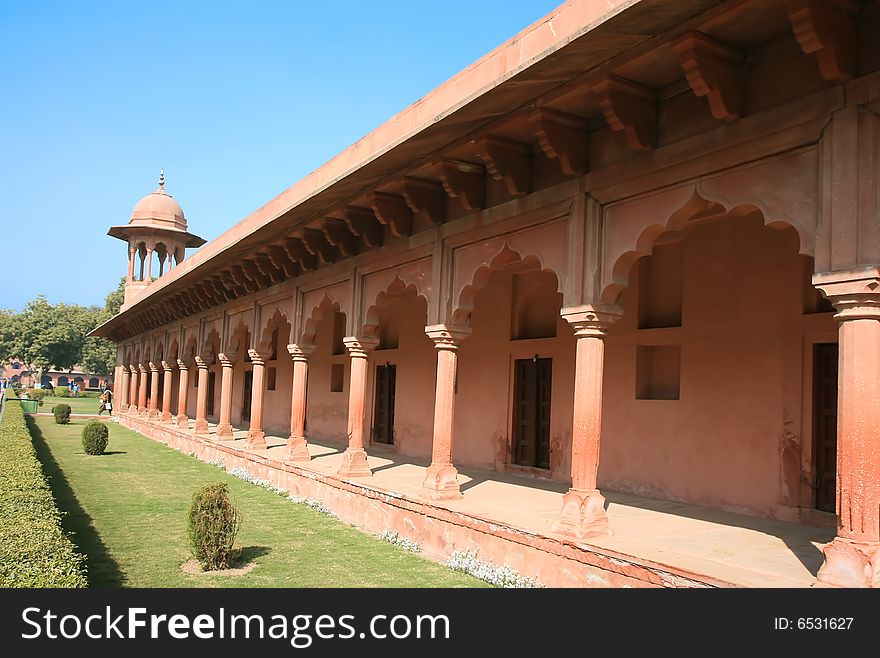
[0, 390, 88, 587]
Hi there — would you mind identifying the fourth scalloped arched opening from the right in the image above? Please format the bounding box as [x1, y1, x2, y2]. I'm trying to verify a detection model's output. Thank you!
[299, 296, 349, 445]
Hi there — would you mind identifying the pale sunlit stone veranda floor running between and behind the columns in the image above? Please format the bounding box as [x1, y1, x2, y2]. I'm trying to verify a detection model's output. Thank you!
[139, 421, 834, 587]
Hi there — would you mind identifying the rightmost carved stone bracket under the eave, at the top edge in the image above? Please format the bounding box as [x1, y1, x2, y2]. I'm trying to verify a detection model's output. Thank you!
[788, 0, 858, 82]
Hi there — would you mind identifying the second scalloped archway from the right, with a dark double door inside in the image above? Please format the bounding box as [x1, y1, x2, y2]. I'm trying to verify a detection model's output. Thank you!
[454, 250, 575, 480]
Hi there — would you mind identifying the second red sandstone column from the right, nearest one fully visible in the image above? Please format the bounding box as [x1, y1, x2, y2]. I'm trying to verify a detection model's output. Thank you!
[553, 306, 621, 539]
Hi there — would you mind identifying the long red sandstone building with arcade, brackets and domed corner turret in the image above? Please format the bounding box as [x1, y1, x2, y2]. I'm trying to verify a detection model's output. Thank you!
[96, 0, 880, 586]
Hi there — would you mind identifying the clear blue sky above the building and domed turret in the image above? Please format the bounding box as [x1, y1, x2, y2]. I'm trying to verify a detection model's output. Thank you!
[0, 0, 561, 310]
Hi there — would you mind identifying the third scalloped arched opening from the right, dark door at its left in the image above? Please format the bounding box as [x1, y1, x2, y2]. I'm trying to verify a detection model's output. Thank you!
[364, 279, 437, 457]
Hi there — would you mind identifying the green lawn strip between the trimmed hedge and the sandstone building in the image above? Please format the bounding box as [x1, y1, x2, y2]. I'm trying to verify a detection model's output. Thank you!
[28, 416, 486, 587]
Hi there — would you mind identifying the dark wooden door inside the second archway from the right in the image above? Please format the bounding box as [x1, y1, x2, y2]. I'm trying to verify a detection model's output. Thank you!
[513, 357, 553, 468]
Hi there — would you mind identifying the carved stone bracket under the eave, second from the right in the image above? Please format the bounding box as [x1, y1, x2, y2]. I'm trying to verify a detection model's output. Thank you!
[672, 32, 743, 121]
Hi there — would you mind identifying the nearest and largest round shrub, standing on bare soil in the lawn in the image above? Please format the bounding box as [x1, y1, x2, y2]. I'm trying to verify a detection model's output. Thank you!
[187, 482, 241, 571]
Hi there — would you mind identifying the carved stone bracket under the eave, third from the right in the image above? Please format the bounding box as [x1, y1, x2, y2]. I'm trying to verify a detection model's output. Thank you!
[594, 77, 657, 151]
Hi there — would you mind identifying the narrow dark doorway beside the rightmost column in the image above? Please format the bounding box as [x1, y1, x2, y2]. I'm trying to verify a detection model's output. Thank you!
[813, 343, 838, 512]
